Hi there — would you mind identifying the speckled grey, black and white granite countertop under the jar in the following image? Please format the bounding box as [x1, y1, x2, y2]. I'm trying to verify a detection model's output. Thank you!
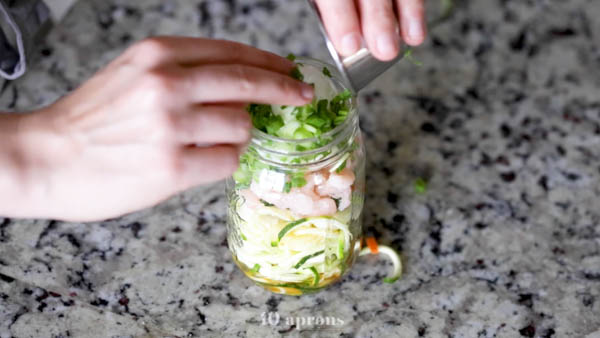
[0, 0, 600, 338]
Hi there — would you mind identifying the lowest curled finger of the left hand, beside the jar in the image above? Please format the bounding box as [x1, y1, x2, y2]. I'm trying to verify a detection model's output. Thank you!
[178, 145, 240, 189]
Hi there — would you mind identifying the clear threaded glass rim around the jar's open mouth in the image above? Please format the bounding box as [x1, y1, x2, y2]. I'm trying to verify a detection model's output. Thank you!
[251, 57, 358, 156]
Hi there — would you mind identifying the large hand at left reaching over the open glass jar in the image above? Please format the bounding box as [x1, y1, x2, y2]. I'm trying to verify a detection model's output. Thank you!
[17, 37, 313, 221]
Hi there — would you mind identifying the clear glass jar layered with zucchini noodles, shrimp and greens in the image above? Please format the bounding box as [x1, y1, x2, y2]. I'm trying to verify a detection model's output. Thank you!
[226, 58, 365, 295]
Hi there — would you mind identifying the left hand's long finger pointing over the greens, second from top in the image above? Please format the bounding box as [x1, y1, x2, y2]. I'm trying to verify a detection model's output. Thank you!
[174, 65, 314, 106]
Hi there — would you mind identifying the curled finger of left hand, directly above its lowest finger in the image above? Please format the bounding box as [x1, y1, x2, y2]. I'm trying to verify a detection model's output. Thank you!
[174, 105, 252, 144]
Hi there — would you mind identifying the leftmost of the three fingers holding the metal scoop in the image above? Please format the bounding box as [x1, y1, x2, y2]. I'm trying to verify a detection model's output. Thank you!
[316, 0, 362, 56]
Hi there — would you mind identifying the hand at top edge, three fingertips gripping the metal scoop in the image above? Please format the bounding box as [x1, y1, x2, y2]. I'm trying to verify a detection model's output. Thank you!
[315, 0, 426, 61]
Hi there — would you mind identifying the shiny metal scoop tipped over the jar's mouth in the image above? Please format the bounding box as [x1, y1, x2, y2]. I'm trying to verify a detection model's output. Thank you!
[307, 0, 403, 93]
